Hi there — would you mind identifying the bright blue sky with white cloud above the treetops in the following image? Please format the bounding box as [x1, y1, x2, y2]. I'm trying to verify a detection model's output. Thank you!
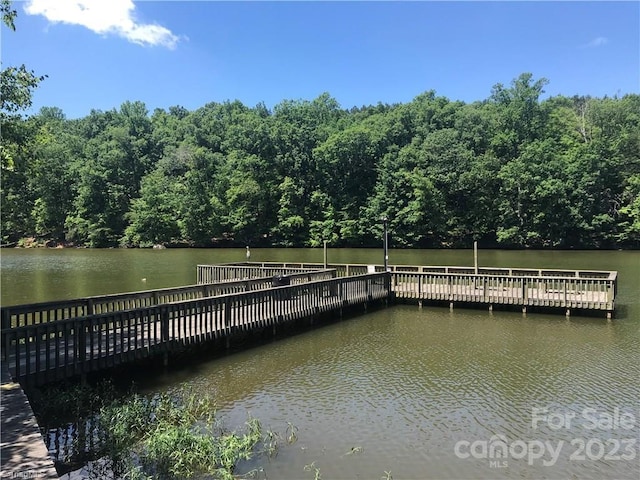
[1, 0, 640, 118]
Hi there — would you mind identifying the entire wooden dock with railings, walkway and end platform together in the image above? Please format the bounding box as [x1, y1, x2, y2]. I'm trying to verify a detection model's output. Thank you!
[1, 262, 617, 384]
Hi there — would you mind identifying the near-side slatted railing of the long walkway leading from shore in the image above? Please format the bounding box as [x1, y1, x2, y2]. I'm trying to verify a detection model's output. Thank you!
[2, 274, 390, 384]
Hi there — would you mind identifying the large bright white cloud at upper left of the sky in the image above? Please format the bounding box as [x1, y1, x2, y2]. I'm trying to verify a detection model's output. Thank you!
[24, 0, 179, 49]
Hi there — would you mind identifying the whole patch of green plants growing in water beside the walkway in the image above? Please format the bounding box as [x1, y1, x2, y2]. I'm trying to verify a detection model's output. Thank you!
[32, 381, 280, 480]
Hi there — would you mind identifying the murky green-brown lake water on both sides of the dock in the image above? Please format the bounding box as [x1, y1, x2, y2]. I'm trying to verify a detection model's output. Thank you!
[1, 249, 640, 480]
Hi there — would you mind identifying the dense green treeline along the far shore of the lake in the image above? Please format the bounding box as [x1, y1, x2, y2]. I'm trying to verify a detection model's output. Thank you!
[1, 74, 640, 248]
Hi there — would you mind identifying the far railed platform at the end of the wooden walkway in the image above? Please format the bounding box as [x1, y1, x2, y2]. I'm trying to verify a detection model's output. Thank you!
[198, 262, 618, 318]
